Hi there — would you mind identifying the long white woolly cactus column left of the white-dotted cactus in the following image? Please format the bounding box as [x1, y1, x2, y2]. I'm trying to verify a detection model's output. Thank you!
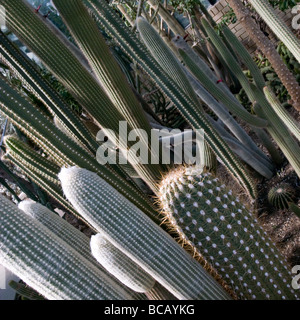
[59, 167, 230, 300]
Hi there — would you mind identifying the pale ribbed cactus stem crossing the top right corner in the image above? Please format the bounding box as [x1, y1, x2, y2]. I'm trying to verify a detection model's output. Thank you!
[249, 0, 300, 63]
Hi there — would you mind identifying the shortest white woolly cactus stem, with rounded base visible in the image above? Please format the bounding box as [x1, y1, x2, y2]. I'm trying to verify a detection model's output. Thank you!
[90, 233, 156, 293]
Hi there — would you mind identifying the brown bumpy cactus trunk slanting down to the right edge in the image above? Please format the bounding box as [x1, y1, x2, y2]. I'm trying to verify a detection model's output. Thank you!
[228, 0, 300, 110]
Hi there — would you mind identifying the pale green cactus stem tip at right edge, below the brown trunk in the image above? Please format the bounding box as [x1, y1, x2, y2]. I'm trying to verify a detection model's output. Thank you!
[264, 87, 300, 142]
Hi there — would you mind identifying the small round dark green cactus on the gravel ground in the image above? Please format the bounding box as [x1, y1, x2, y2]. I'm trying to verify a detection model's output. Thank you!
[268, 183, 295, 210]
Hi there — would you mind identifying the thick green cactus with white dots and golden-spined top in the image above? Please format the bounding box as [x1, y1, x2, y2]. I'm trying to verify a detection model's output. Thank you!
[159, 167, 299, 299]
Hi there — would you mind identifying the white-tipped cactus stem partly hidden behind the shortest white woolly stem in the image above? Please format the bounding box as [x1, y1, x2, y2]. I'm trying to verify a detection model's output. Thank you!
[18, 200, 146, 299]
